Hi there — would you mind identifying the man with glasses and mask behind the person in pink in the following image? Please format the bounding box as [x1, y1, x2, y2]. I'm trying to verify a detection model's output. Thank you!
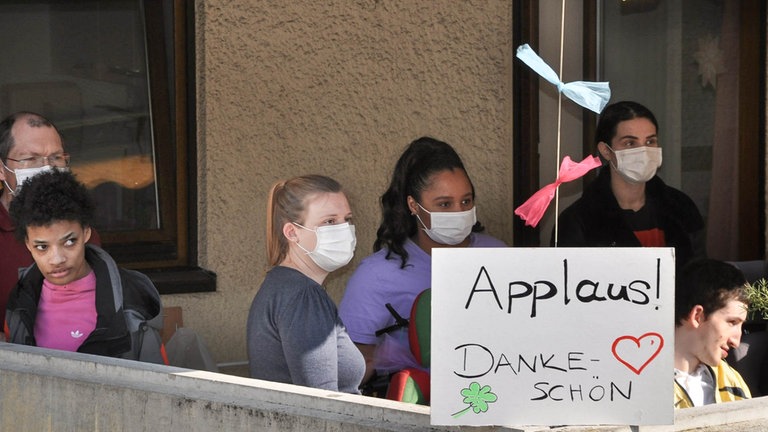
[0, 112, 101, 322]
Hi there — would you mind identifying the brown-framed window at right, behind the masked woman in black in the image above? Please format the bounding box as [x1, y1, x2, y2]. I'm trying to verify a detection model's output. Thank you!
[588, 0, 766, 261]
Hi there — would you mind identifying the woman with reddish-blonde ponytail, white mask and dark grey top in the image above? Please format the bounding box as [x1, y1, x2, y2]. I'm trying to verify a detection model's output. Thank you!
[247, 175, 365, 393]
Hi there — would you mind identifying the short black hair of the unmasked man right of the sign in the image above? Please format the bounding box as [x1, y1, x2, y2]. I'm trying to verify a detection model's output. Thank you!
[675, 258, 749, 326]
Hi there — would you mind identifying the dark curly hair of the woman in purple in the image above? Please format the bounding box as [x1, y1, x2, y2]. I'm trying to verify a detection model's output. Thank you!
[373, 137, 483, 268]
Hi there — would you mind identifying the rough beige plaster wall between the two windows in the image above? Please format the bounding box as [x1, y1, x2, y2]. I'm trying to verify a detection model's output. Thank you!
[163, 0, 514, 362]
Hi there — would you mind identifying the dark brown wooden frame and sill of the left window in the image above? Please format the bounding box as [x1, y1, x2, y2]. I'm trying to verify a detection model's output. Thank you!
[99, 0, 216, 294]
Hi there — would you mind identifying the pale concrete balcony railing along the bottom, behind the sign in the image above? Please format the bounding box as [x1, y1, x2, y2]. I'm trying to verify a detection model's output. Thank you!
[0, 343, 768, 432]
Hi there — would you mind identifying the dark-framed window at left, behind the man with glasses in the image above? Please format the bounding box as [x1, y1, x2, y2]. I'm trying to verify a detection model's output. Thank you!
[0, 0, 215, 294]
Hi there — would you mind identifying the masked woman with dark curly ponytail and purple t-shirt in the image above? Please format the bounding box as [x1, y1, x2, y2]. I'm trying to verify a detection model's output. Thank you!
[339, 137, 505, 382]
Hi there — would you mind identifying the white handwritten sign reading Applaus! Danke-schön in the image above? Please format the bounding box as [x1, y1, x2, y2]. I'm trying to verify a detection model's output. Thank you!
[431, 248, 675, 426]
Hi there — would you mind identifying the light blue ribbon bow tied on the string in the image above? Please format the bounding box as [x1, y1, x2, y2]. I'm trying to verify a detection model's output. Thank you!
[517, 44, 611, 114]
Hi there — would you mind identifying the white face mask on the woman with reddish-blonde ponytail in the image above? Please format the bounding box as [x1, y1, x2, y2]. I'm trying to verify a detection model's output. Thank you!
[293, 222, 357, 273]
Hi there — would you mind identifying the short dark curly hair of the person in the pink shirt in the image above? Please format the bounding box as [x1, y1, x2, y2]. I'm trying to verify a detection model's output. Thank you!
[8, 169, 96, 242]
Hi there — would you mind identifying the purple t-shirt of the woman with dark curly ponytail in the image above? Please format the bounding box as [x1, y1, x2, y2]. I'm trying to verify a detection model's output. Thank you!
[339, 233, 507, 370]
